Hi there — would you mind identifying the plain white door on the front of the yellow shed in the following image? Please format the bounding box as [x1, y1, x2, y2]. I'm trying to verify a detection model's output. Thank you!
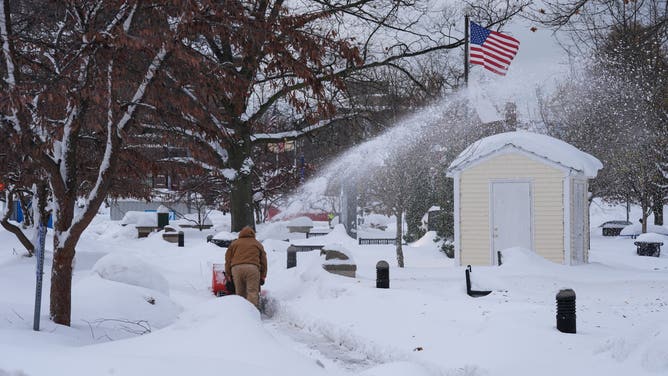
[491, 182, 533, 264]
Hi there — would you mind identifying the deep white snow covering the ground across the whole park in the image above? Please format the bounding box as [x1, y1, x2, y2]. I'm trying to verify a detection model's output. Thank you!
[0, 203, 668, 376]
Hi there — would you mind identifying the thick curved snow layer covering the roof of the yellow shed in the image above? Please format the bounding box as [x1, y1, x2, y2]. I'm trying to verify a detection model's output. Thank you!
[448, 131, 603, 178]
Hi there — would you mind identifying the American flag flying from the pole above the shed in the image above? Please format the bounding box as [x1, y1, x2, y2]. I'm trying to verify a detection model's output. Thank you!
[470, 22, 520, 76]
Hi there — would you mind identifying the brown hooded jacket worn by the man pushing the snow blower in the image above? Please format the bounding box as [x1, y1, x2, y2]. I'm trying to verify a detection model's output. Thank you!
[225, 226, 267, 279]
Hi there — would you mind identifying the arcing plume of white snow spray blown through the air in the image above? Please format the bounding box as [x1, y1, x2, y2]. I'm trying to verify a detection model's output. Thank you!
[278, 70, 564, 218]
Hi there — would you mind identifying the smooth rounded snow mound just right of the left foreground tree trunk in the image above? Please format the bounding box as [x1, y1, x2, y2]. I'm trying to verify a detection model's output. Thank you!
[92, 253, 169, 295]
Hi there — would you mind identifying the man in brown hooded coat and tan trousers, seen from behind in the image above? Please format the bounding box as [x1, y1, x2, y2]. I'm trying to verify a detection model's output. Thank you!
[225, 226, 267, 308]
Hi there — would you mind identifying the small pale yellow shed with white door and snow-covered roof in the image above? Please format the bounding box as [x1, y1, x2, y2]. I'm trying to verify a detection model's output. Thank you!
[447, 131, 603, 265]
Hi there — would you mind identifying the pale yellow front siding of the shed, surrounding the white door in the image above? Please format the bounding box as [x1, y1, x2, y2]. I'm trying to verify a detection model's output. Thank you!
[460, 153, 564, 265]
